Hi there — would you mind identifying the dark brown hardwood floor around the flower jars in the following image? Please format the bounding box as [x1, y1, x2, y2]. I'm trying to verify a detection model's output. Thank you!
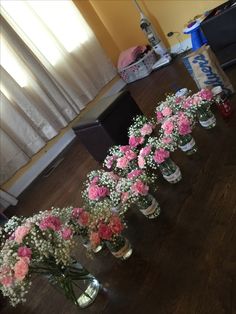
[0, 59, 236, 314]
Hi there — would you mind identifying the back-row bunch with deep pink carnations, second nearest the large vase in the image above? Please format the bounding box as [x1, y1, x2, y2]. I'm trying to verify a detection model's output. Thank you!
[82, 169, 120, 209]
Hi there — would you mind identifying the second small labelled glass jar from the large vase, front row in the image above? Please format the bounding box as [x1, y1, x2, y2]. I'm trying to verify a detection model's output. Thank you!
[137, 194, 161, 219]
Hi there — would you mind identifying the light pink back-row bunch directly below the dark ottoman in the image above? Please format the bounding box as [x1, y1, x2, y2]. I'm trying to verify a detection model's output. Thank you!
[104, 145, 138, 176]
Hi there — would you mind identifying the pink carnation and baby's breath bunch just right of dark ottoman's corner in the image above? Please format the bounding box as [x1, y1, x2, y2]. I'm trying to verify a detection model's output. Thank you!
[128, 115, 155, 148]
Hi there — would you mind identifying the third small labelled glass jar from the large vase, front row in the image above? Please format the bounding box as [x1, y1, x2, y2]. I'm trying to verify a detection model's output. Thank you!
[158, 158, 182, 184]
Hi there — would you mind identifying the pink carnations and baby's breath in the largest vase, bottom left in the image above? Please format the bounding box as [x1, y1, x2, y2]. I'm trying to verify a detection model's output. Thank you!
[0, 209, 75, 306]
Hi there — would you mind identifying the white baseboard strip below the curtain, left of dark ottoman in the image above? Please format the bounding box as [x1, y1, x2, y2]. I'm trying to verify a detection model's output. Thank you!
[7, 129, 76, 197]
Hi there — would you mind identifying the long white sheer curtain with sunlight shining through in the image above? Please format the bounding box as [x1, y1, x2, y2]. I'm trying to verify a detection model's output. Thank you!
[0, 0, 116, 184]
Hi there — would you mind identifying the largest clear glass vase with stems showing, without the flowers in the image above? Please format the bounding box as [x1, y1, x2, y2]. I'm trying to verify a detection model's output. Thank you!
[46, 260, 100, 308]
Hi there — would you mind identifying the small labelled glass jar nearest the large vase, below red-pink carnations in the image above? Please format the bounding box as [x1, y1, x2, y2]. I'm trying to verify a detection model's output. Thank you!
[106, 235, 133, 260]
